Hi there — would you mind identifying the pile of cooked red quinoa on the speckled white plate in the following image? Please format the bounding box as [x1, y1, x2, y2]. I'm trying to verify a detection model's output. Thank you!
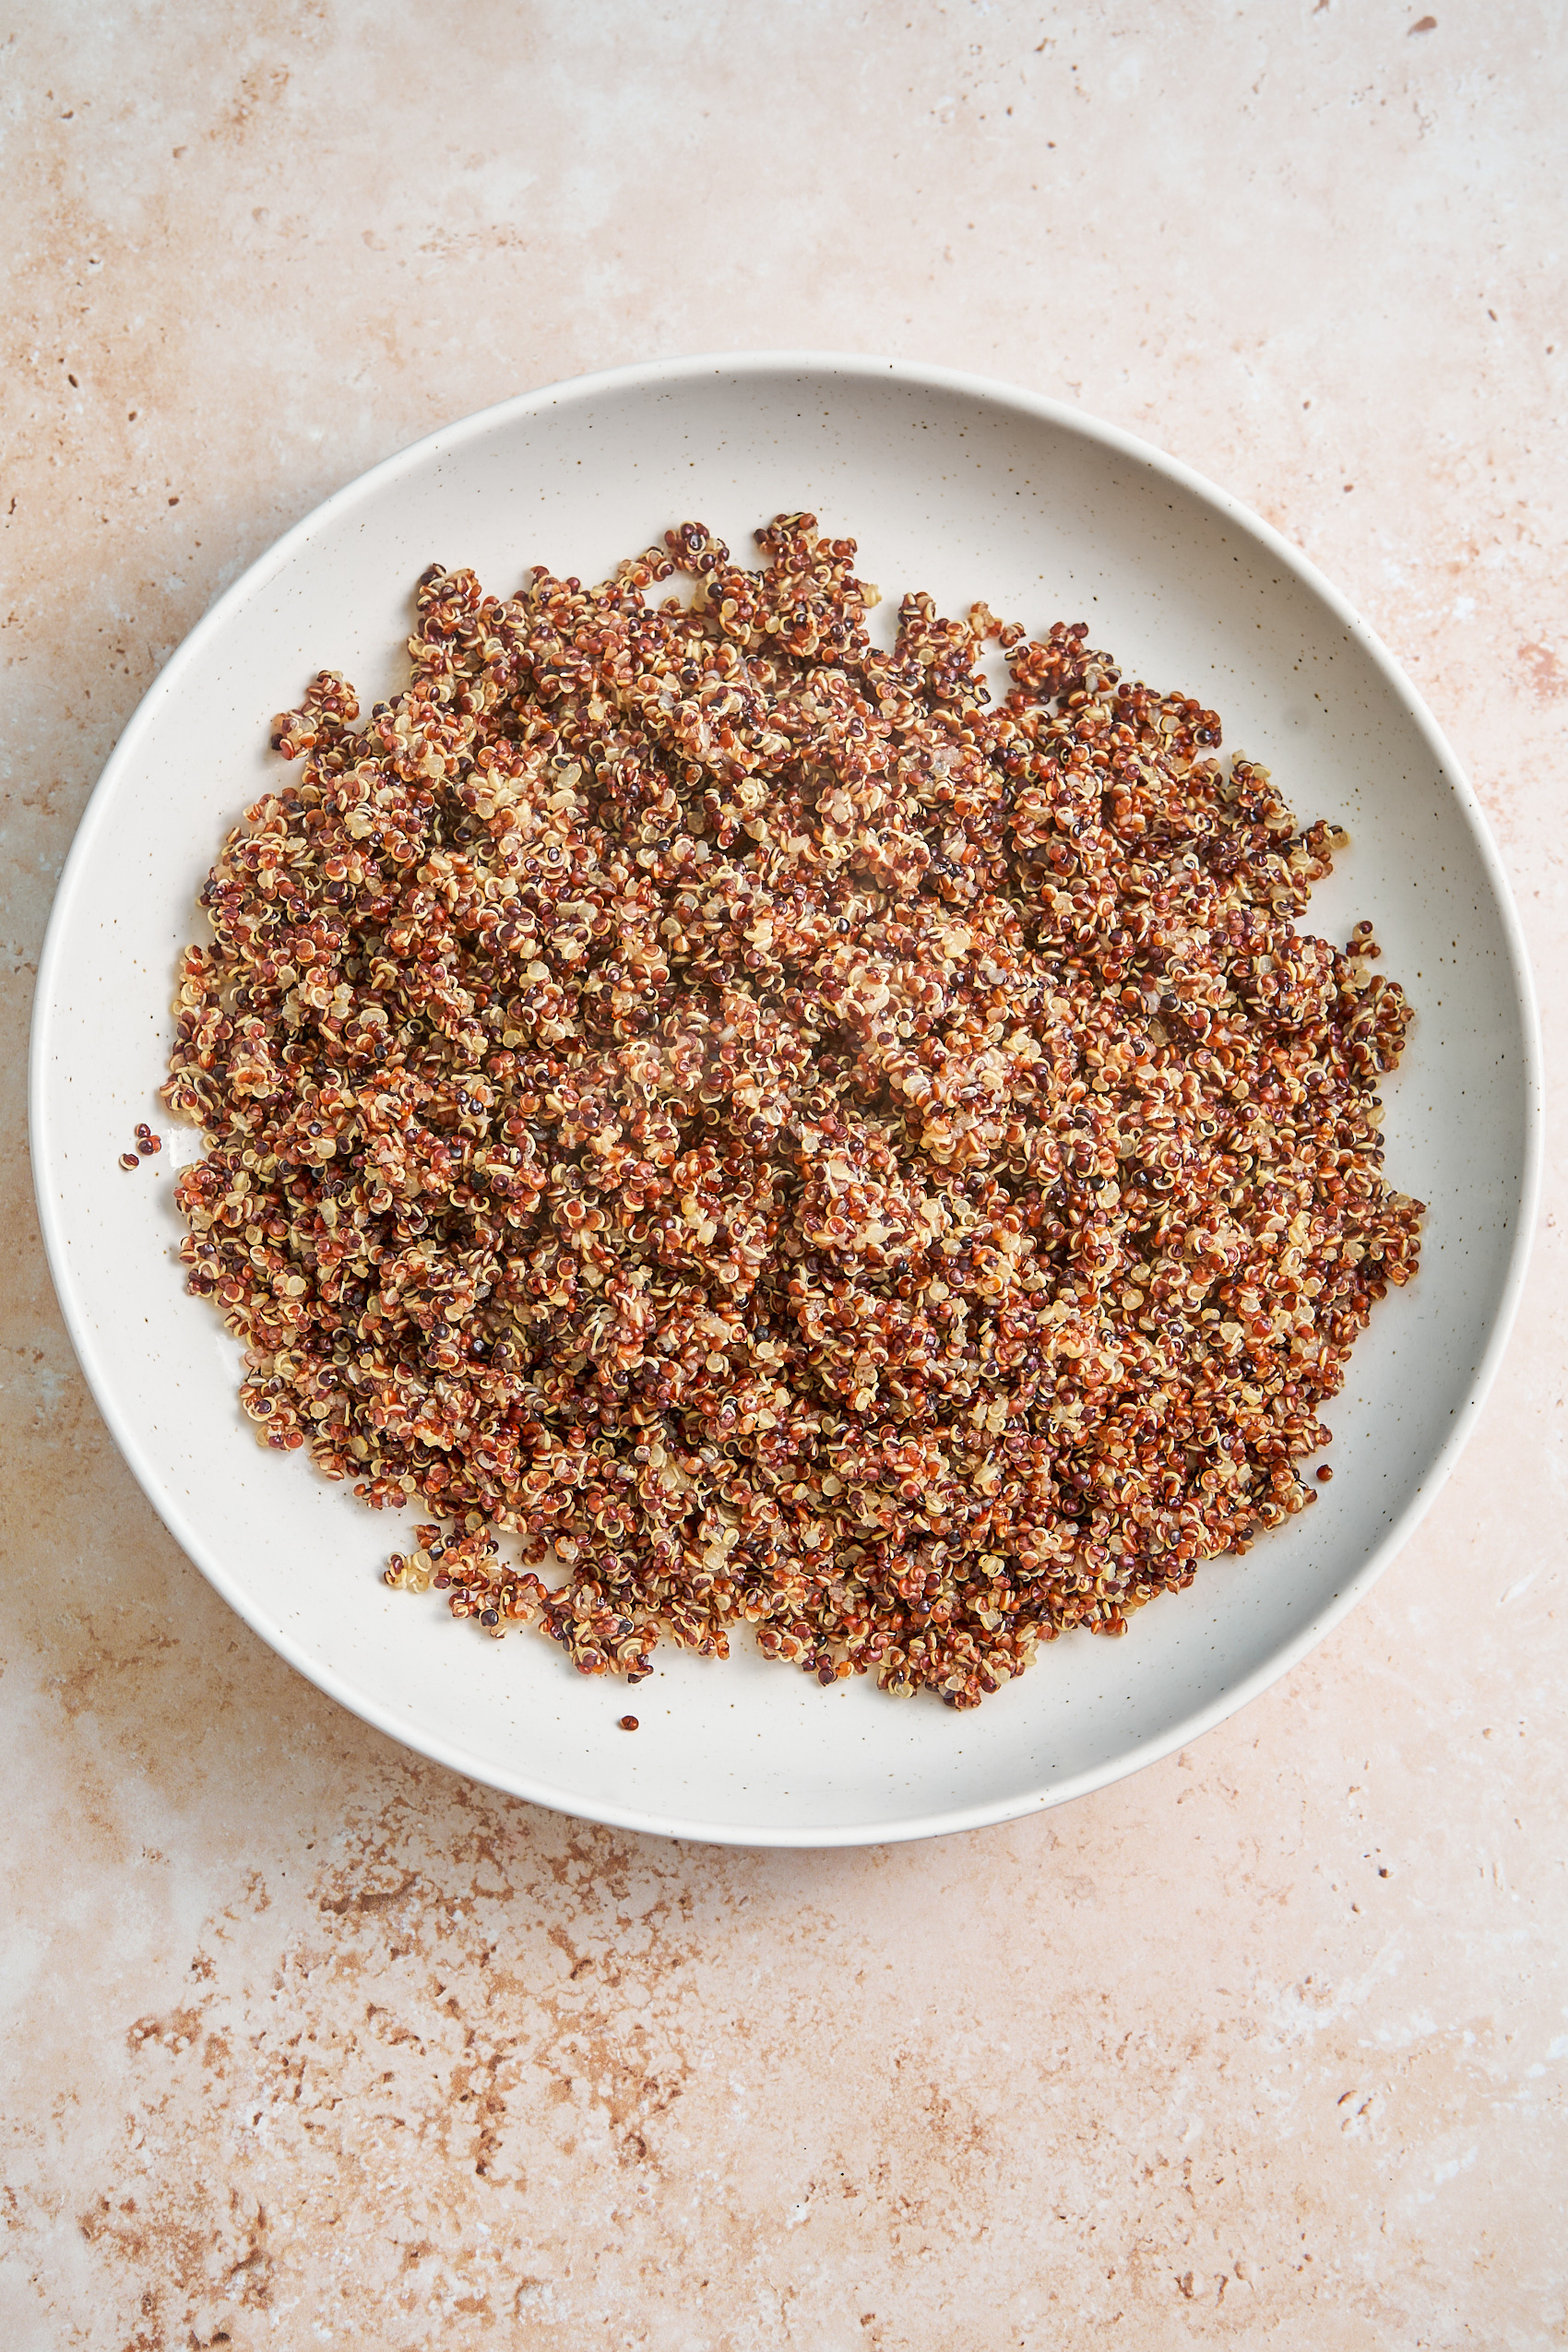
[162, 515, 1422, 1707]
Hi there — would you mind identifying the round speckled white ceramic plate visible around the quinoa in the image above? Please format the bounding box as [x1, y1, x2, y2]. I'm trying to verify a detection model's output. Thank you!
[30, 353, 1539, 1847]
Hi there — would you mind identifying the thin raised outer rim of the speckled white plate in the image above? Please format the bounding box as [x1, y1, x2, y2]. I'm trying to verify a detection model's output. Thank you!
[29, 348, 1545, 1848]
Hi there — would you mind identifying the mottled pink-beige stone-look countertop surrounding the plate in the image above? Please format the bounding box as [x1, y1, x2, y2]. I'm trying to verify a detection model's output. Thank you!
[0, 0, 1568, 2352]
